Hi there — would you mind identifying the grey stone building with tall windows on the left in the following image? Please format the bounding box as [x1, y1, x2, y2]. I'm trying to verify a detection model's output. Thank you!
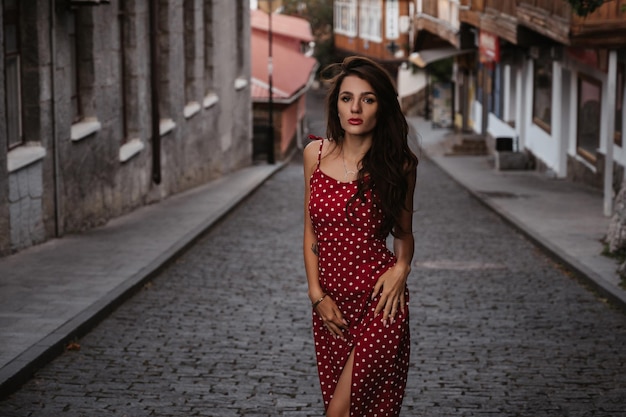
[0, 0, 252, 255]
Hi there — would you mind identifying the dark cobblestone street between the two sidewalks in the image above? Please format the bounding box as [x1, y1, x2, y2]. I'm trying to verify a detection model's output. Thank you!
[0, 151, 626, 417]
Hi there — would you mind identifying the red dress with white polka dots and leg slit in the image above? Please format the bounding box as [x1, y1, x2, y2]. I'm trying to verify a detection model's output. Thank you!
[309, 141, 410, 417]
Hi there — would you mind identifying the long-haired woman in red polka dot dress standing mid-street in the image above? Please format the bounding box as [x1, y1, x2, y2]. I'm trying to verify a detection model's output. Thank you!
[304, 57, 418, 417]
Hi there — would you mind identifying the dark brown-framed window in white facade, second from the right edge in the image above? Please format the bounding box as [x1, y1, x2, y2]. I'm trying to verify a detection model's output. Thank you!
[576, 75, 602, 162]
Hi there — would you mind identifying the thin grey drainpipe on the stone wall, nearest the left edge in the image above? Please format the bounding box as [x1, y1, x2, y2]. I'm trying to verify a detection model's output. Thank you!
[48, 0, 63, 237]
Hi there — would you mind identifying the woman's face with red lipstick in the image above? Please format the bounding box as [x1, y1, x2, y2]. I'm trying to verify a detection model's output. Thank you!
[337, 75, 378, 136]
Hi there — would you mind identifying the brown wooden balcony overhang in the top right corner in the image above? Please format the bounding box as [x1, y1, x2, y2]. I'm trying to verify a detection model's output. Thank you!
[517, 0, 626, 48]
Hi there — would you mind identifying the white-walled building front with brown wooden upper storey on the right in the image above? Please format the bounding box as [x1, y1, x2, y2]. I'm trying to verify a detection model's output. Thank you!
[415, 0, 626, 215]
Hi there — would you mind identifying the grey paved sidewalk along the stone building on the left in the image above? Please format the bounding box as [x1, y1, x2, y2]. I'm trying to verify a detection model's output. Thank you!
[0, 163, 284, 398]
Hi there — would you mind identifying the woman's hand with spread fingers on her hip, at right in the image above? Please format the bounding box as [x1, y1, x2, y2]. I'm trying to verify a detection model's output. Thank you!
[372, 264, 409, 324]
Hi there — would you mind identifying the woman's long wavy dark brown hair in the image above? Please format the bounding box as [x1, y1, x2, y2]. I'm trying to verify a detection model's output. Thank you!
[322, 56, 418, 237]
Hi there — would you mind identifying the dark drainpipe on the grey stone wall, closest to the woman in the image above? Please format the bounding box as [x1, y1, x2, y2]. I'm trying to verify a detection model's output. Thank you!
[149, 0, 161, 184]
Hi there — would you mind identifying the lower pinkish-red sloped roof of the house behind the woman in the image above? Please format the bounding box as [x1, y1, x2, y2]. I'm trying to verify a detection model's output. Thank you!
[250, 33, 318, 101]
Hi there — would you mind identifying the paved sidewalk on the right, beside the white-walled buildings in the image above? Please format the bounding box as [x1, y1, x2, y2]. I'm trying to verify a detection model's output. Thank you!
[409, 117, 626, 310]
